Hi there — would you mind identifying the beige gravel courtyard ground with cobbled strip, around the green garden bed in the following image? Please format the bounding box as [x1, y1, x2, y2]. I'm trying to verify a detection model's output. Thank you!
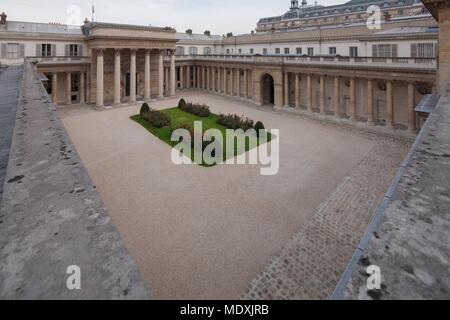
[58, 91, 408, 299]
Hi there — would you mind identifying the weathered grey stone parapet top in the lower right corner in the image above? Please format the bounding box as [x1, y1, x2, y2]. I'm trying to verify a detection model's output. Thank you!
[342, 85, 450, 300]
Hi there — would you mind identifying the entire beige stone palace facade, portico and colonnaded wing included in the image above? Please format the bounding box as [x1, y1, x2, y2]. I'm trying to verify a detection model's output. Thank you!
[0, 7, 437, 133]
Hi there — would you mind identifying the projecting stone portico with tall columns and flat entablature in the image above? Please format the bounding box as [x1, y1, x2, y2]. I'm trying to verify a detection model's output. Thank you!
[85, 23, 176, 108]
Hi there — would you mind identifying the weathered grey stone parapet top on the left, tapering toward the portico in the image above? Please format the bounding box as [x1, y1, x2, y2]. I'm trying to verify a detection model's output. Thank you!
[0, 64, 149, 299]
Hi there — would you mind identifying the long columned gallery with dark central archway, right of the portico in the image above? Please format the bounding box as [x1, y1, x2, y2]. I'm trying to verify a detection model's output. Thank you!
[170, 56, 436, 133]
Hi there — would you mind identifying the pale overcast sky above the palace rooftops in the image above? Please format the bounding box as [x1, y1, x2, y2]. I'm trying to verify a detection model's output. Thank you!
[0, 0, 347, 34]
